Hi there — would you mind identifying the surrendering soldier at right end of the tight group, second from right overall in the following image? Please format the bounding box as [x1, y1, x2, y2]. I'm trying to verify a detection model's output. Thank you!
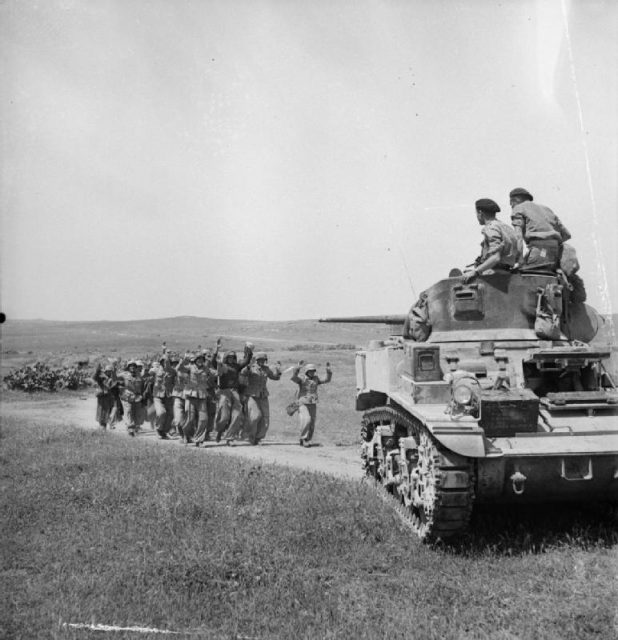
[239, 351, 281, 444]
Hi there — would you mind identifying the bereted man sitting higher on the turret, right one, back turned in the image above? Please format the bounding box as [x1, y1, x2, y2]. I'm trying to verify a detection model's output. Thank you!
[509, 187, 571, 271]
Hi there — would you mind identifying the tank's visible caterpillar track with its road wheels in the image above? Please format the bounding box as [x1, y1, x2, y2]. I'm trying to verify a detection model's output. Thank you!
[361, 406, 474, 542]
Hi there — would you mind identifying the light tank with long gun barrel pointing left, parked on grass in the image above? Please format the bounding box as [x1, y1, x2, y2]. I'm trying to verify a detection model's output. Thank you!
[322, 273, 618, 542]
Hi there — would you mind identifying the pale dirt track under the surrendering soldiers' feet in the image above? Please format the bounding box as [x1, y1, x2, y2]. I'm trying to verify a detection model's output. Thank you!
[1, 397, 363, 479]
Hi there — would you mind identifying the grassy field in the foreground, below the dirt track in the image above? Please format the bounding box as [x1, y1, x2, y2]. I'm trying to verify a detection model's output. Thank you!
[0, 418, 618, 640]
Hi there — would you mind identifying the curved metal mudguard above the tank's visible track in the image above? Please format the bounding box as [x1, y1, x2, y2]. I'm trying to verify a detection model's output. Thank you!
[389, 393, 488, 458]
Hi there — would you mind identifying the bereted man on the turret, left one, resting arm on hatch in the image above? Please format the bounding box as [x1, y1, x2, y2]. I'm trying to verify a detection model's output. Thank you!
[463, 198, 522, 282]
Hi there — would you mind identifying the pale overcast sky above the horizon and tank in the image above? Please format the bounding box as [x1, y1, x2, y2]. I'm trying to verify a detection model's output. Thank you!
[0, 0, 618, 320]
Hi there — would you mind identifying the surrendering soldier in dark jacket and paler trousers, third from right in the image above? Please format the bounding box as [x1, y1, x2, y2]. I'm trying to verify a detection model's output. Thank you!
[215, 342, 253, 441]
